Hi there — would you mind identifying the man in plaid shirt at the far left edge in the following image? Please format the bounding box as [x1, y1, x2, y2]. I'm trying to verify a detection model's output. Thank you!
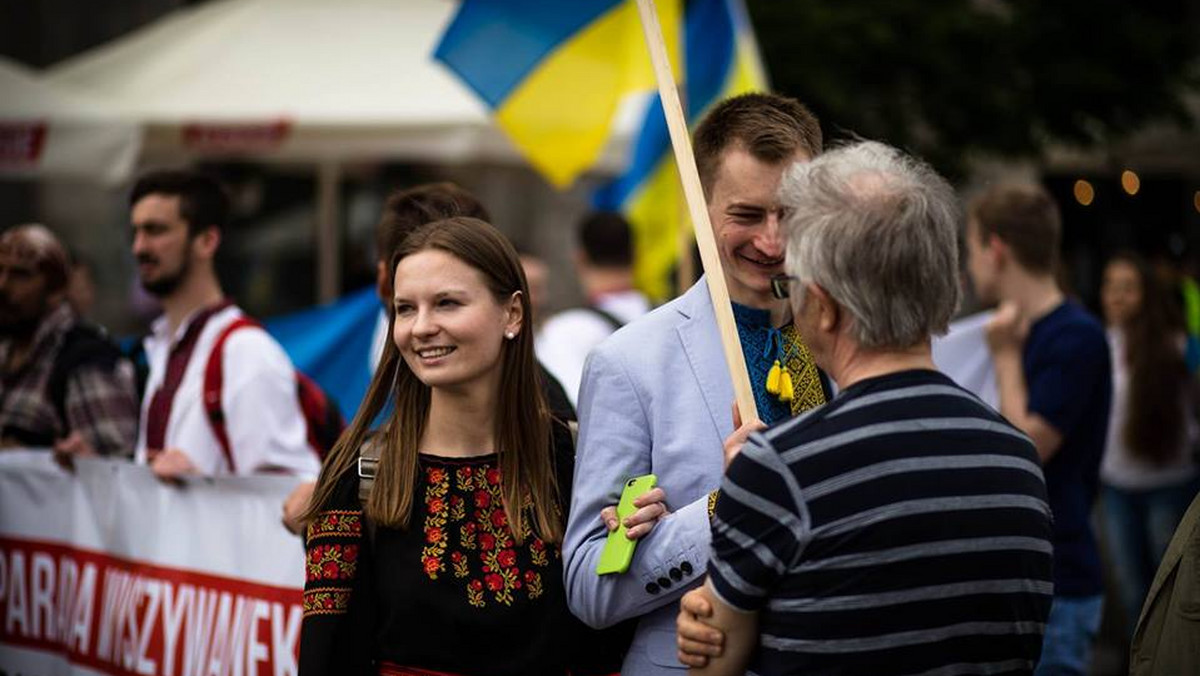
[0, 225, 138, 456]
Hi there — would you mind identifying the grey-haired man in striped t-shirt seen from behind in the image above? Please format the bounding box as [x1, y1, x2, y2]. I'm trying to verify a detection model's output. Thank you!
[679, 143, 1052, 674]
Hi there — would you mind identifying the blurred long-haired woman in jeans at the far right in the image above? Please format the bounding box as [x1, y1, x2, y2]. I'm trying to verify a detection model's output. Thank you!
[1100, 252, 1200, 632]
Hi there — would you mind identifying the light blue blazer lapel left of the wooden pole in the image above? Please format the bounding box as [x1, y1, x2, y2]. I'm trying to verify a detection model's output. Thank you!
[667, 277, 733, 442]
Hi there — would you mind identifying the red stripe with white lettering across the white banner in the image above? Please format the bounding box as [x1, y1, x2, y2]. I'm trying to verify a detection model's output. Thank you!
[0, 538, 302, 676]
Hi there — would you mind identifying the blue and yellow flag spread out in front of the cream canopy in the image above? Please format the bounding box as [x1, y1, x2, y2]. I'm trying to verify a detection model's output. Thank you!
[434, 0, 680, 187]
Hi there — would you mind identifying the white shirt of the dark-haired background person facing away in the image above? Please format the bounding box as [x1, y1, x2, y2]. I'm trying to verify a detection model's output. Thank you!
[534, 291, 650, 406]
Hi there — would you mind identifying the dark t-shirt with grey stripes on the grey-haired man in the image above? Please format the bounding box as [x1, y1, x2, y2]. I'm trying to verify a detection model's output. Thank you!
[708, 371, 1054, 676]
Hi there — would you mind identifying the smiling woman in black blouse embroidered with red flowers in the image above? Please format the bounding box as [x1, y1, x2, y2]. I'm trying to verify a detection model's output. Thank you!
[300, 217, 619, 675]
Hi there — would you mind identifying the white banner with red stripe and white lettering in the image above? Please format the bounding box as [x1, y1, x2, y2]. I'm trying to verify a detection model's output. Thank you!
[0, 450, 304, 676]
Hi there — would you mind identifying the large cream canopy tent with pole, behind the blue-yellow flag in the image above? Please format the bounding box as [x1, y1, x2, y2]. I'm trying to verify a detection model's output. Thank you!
[47, 0, 644, 300]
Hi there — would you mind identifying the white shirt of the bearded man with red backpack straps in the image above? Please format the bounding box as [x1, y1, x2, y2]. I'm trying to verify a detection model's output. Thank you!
[134, 305, 320, 478]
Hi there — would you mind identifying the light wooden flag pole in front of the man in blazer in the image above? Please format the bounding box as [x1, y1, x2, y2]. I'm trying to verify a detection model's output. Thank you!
[637, 0, 758, 423]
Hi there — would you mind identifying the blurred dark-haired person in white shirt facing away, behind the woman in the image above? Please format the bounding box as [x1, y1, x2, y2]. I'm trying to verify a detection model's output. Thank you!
[536, 211, 650, 405]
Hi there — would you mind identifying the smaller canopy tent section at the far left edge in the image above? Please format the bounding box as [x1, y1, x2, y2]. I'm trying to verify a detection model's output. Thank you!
[0, 56, 142, 184]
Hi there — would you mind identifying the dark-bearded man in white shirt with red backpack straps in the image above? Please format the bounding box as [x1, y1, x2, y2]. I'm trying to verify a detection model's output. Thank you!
[130, 171, 320, 479]
